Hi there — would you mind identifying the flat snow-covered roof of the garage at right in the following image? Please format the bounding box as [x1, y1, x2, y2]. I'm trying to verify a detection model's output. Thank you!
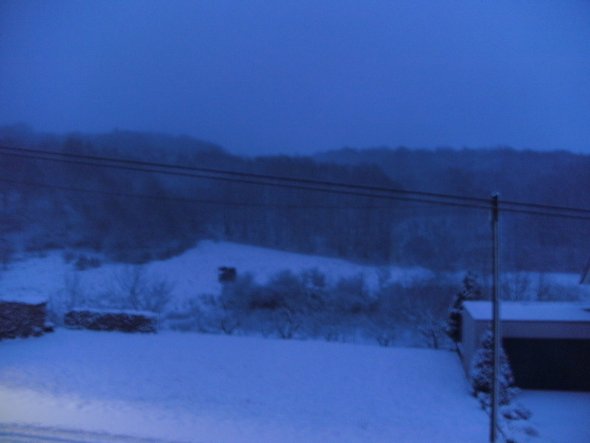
[463, 301, 590, 323]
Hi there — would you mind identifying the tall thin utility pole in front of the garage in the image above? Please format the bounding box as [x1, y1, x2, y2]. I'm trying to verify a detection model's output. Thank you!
[490, 194, 502, 443]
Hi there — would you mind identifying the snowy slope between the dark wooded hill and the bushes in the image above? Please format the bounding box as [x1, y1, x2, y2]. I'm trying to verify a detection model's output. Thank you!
[0, 240, 431, 301]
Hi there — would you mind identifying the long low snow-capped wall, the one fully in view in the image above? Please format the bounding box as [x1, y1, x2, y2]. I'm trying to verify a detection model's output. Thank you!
[64, 309, 157, 332]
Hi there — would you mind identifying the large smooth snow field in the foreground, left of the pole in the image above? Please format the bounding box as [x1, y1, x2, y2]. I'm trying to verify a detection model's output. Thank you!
[0, 329, 488, 443]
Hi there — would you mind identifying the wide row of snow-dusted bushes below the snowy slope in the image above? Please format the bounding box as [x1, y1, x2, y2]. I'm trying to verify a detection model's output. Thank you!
[191, 269, 452, 348]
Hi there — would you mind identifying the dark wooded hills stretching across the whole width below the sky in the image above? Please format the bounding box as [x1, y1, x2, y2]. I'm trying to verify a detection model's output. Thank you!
[0, 126, 590, 272]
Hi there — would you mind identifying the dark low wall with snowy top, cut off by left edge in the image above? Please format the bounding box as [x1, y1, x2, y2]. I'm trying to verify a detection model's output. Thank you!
[0, 300, 52, 339]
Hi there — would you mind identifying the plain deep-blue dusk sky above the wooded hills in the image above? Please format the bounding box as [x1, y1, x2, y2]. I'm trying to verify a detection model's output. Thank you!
[0, 0, 590, 154]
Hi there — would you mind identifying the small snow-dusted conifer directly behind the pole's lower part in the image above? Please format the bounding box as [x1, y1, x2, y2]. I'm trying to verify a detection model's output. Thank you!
[470, 329, 517, 405]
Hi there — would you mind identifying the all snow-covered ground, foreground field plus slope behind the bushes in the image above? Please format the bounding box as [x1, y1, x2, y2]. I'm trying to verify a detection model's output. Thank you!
[0, 245, 590, 443]
